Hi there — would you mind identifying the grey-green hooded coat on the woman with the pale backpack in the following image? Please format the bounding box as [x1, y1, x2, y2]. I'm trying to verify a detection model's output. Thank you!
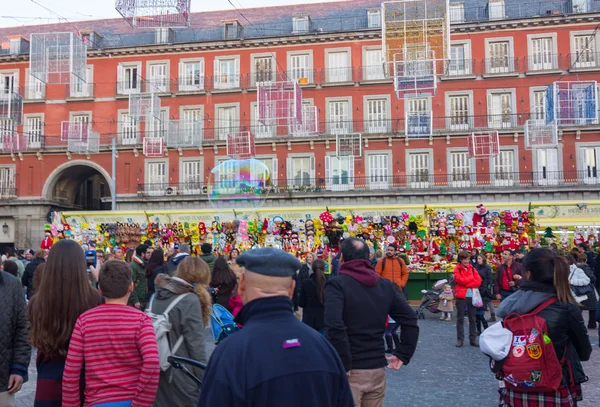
[149, 274, 208, 407]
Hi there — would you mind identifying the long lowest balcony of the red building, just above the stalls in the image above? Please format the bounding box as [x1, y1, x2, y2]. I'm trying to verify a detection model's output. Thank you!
[138, 170, 600, 197]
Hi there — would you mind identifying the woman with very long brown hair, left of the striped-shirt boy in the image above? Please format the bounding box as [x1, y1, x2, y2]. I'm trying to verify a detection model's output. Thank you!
[27, 240, 102, 407]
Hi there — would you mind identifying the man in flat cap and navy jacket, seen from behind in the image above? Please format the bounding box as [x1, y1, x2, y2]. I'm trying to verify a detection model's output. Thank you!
[198, 248, 354, 407]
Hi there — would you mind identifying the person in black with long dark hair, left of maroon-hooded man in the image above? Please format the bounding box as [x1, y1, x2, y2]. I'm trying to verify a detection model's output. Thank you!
[298, 259, 326, 336]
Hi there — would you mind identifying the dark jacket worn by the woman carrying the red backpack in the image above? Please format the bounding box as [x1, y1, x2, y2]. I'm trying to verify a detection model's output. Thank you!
[496, 281, 592, 385]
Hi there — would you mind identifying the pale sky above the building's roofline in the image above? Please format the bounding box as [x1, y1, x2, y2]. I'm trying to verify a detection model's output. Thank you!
[0, 0, 338, 27]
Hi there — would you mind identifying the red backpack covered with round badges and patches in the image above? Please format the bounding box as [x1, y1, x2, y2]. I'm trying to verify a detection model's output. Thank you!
[499, 297, 563, 393]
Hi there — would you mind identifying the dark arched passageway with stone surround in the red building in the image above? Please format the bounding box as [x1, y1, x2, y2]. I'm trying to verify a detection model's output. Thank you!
[42, 160, 113, 211]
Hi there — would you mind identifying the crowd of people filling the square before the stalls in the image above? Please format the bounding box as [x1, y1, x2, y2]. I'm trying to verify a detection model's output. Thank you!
[0, 238, 600, 407]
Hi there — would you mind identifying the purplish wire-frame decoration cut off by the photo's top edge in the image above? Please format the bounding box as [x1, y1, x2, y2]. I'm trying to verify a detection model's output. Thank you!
[115, 0, 191, 28]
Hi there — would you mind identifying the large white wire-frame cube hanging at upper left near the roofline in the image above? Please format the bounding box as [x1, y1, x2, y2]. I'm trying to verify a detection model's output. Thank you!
[29, 32, 87, 84]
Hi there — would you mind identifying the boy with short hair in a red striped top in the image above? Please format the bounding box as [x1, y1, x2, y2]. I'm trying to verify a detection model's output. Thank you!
[62, 260, 160, 407]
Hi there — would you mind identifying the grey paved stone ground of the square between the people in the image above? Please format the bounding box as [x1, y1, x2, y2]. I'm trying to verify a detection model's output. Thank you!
[16, 312, 600, 407]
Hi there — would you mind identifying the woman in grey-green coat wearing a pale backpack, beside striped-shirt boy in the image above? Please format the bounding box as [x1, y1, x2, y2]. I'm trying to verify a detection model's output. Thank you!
[148, 256, 211, 407]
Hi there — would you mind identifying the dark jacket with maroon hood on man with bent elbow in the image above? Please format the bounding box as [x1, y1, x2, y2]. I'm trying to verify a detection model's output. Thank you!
[325, 260, 419, 370]
